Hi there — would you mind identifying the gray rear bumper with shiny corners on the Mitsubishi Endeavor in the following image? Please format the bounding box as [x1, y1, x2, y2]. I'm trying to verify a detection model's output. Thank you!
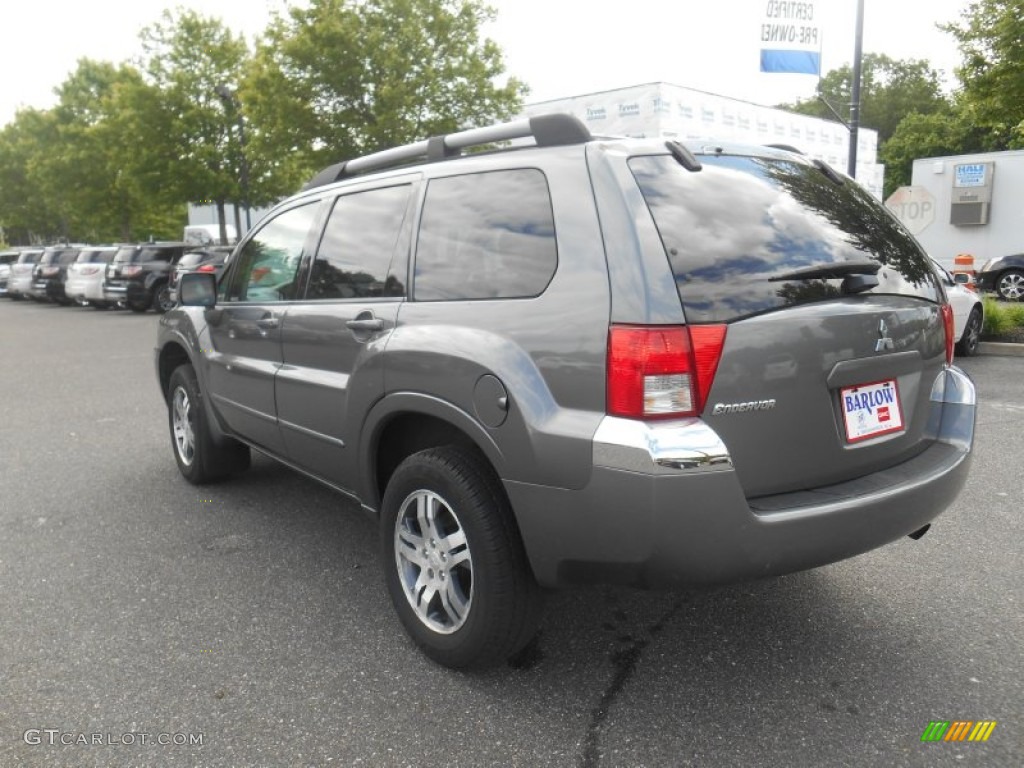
[505, 368, 975, 586]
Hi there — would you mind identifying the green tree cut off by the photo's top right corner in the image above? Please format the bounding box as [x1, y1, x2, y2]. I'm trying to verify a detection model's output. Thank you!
[942, 0, 1024, 150]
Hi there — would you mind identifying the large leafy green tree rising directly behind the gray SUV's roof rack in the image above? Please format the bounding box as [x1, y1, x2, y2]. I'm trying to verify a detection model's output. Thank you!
[241, 0, 526, 194]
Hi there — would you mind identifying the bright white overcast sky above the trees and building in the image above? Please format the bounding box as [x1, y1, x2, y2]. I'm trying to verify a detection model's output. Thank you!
[0, 0, 969, 125]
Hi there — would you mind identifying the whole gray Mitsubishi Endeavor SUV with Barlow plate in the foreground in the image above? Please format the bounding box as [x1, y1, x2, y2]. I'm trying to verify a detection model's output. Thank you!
[156, 115, 975, 667]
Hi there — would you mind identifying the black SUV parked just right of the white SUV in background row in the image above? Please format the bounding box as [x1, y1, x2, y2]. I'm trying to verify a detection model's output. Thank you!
[103, 243, 185, 313]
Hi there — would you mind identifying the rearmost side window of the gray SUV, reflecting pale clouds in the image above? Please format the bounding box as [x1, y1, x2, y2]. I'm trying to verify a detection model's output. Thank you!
[415, 169, 558, 301]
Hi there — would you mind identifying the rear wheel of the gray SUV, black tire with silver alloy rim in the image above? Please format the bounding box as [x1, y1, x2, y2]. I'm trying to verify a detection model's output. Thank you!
[381, 445, 542, 669]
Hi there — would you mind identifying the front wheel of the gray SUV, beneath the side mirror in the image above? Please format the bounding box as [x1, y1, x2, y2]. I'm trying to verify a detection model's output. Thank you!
[167, 364, 252, 485]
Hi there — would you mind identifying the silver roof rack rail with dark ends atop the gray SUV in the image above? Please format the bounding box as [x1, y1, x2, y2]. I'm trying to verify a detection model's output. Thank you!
[302, 114, 592, 189]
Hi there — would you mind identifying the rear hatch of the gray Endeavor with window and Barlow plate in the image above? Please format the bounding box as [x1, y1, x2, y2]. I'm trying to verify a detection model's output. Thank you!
[630, 152, 946, 497]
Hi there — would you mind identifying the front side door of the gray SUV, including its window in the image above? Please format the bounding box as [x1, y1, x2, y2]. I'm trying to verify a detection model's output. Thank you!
[203, 202, 317, 455]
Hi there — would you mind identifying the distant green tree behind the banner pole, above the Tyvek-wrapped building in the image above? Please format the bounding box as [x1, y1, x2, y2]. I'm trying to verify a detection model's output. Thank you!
[781, 53, 950, 144]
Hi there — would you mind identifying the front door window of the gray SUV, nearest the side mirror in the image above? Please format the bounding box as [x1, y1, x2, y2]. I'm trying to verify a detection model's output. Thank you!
[220, 204, 316, 302]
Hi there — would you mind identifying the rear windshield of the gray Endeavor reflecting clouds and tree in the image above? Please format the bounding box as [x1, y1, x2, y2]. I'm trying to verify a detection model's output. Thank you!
[630, 155, 943, 323]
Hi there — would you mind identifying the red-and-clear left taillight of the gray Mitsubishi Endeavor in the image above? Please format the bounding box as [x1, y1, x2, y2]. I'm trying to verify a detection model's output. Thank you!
[607, 326, 726, 419]
